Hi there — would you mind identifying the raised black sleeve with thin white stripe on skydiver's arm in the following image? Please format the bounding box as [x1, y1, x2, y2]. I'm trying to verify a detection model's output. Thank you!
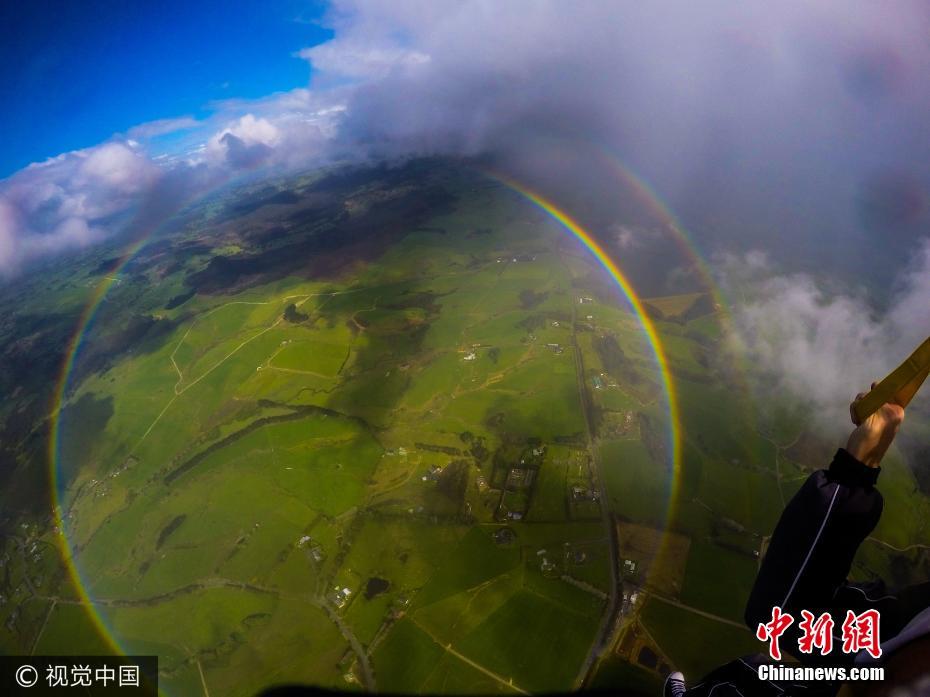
[745, 448, 883, 631]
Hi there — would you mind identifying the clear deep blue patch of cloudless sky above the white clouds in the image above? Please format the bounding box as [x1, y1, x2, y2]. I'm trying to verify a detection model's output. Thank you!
[0, 0, 331, 177]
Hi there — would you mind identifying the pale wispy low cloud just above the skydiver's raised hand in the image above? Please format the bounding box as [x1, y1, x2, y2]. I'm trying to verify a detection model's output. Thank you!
[720, 239, 930, 428]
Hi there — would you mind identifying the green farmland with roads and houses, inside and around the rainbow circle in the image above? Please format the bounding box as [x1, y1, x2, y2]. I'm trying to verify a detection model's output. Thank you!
[0, 164, 930, 695]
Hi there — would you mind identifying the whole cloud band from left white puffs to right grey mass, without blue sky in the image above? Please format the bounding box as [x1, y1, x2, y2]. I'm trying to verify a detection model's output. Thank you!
[0, 0, 930, 302]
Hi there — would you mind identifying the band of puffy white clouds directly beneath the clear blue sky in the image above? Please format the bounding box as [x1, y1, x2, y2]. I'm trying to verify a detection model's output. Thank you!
[0, 90, 339, 278]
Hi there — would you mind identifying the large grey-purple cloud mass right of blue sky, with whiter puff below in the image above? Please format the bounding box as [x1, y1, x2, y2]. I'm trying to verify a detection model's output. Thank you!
[302, 0, 930, 416]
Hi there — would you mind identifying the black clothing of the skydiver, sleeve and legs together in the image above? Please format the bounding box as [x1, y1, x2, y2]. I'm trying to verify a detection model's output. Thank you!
[686, 449, 930, 697]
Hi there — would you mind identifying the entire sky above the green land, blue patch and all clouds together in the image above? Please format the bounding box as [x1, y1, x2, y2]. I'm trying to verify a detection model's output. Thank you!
[0, 0, 930, 413]
